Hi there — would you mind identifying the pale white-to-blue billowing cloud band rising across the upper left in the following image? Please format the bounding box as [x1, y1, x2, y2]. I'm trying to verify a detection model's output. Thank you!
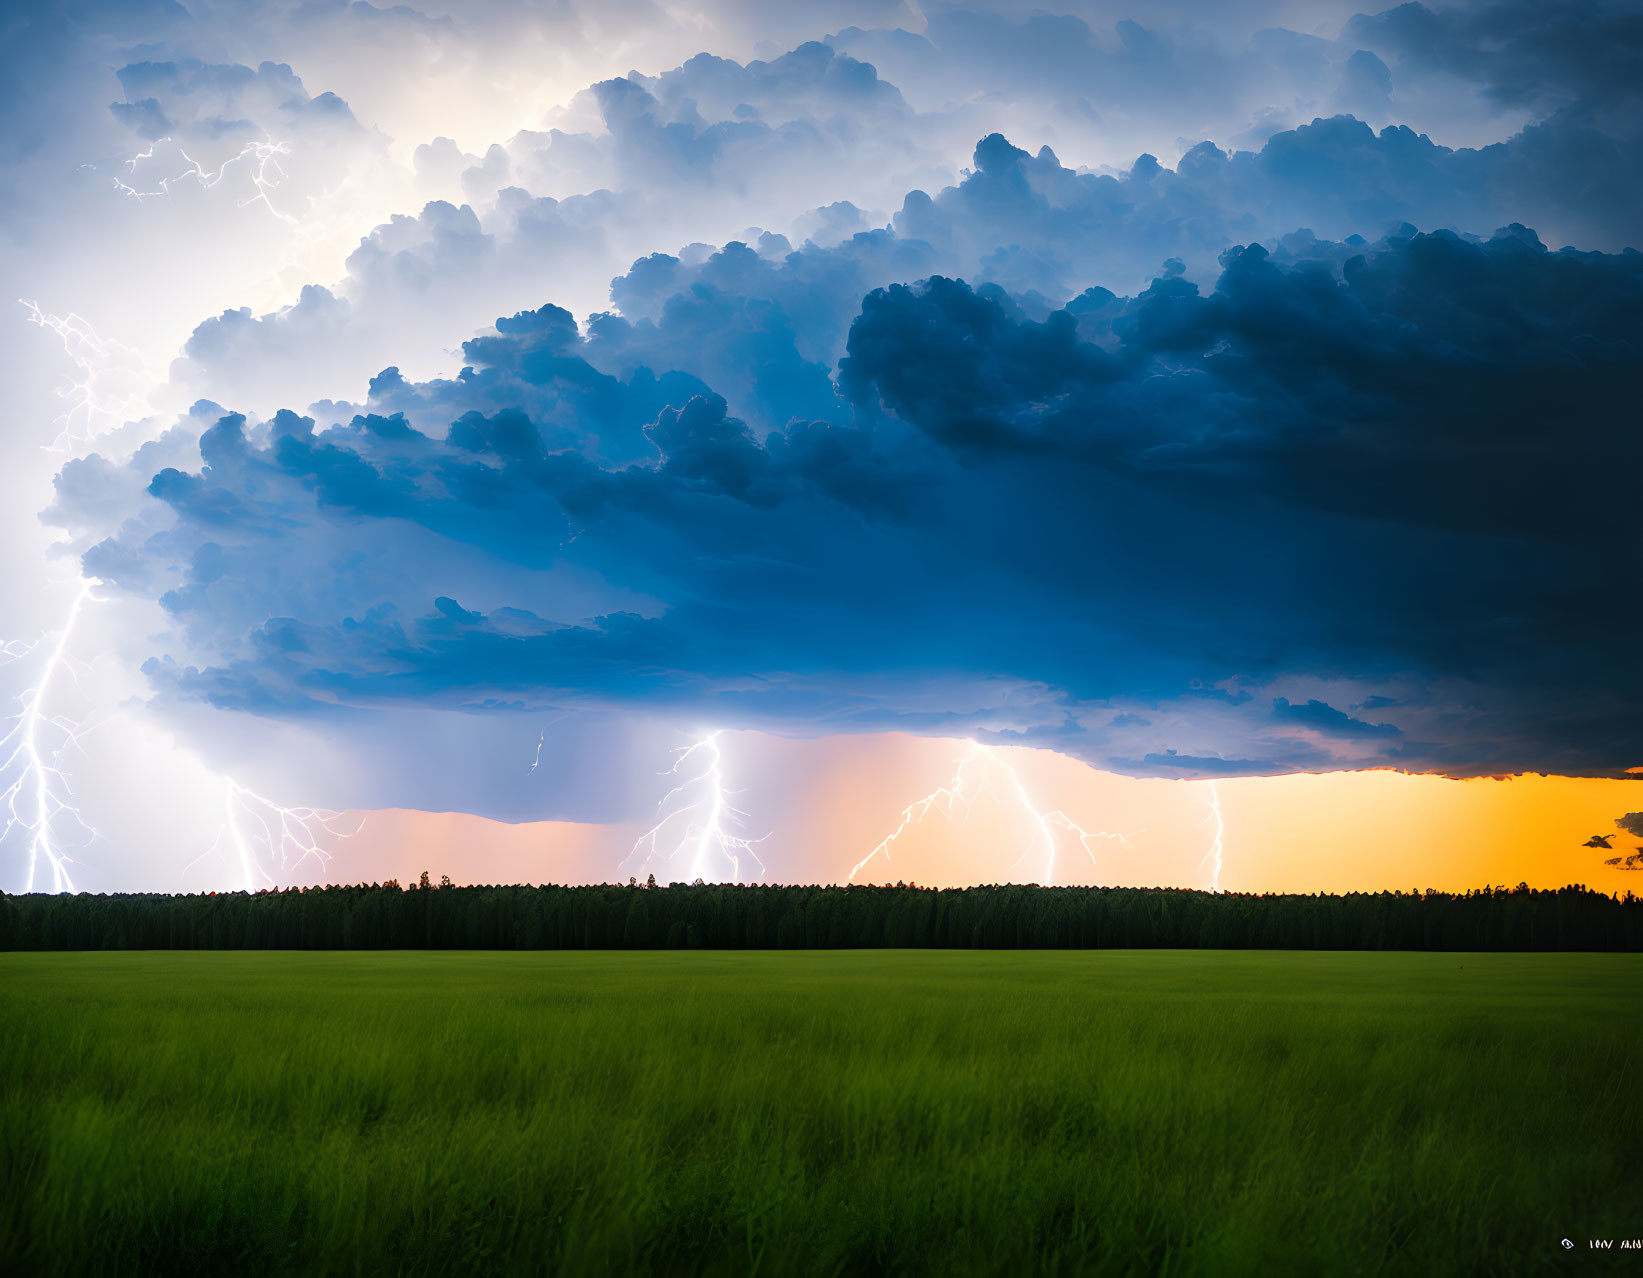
[158, 44, 960, 412]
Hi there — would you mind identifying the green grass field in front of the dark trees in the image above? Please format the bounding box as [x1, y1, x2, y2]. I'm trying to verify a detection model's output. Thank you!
[0, 951, 1643, 1276]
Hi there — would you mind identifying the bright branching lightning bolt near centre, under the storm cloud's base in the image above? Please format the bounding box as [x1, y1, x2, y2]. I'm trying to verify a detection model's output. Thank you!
[621, 733, 767, 882]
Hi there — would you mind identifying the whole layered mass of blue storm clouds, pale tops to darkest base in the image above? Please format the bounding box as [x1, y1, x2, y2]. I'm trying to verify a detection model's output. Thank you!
[16, 5, 1643, 808]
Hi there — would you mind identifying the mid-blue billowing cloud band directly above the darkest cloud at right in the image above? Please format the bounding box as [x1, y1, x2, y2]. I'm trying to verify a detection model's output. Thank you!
[895, 117, 1643, 280]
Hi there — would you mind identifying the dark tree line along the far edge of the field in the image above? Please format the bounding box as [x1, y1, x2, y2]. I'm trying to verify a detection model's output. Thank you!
[0, 884, 1643, 951]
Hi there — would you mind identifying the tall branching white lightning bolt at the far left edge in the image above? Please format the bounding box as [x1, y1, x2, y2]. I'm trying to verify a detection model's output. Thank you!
[0, 582, 97, 892]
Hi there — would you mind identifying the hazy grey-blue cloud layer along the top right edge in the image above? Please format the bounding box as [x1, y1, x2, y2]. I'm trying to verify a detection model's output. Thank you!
[830, 0, 1643, 161]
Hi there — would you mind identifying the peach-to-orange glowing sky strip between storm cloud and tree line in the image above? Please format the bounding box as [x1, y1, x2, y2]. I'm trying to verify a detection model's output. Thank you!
[308, 733, 1643, 892]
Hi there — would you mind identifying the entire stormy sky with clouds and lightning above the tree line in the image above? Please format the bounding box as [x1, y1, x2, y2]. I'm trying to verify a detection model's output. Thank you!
[0, 0, 1643, 892]
